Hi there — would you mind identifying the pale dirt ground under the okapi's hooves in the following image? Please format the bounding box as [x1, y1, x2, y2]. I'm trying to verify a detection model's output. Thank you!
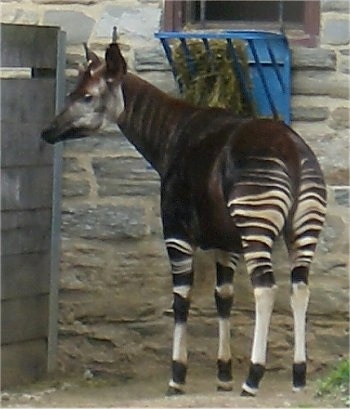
[2, 370, 345, 408]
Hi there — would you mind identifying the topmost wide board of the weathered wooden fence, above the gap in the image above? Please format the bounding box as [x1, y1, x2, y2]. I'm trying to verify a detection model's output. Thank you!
[0, 24, 59, 69]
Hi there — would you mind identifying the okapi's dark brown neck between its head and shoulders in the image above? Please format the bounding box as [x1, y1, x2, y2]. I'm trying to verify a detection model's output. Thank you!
[118, 74, 198, 176]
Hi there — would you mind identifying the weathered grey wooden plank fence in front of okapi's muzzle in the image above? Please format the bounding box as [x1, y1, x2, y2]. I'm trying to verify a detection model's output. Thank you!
[1, 24, 63, 387]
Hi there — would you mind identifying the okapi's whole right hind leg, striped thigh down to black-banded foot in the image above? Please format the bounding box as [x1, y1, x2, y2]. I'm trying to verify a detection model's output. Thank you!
[285, 161, 327, 391]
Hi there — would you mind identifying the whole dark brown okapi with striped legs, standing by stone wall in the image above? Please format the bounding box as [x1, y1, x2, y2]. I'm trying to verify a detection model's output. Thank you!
[42, 40, 326, 396]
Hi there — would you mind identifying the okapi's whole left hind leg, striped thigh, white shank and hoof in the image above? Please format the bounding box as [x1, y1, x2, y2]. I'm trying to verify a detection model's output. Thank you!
[227, 162, 292, 396]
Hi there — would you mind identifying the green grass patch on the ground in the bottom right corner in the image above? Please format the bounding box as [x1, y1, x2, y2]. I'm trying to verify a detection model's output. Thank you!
[317, 359, 350, 406]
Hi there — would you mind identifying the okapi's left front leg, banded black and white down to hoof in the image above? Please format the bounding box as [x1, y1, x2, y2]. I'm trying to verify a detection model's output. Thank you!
[166, 239, 193, 395]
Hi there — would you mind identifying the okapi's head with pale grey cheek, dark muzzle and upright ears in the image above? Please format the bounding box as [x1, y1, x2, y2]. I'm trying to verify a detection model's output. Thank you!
[41, 37, 126, 144]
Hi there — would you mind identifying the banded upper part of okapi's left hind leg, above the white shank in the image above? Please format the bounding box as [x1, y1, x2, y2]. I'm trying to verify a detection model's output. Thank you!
[227, 156, 293, 285]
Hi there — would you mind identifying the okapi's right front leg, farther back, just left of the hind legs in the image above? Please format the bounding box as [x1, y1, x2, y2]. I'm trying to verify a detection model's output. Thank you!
[214, 250, 240, 391]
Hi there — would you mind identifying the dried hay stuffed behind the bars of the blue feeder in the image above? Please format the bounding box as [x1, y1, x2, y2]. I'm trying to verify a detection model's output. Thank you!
[173, 40, 255, 115]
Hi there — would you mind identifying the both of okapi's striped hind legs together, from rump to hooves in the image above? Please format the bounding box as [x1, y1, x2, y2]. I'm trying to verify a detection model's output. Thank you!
[227, 152, 326, 395]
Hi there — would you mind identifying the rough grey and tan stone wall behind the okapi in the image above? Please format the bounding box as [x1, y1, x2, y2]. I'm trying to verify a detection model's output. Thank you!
[2, 0, 350, 378]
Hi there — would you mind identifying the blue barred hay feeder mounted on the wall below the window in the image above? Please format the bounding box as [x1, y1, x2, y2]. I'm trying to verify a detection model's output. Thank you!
[155, 30, 291, 124]
